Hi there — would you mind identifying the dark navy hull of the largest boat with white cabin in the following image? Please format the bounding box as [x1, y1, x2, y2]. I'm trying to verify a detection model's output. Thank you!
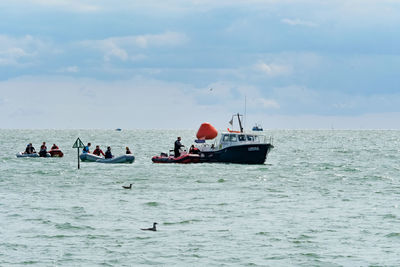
[200, 144, 274, 164]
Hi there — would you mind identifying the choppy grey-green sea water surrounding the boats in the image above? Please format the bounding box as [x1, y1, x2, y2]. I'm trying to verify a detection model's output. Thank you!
[0, 130, 400, 266]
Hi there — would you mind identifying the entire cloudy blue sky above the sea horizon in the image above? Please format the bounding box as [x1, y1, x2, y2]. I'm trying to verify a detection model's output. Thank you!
[0, 0, 400, 129]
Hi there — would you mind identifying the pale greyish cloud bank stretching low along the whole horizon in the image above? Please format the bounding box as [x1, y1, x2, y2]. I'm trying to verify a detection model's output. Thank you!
[0, 76, 400, 129]
